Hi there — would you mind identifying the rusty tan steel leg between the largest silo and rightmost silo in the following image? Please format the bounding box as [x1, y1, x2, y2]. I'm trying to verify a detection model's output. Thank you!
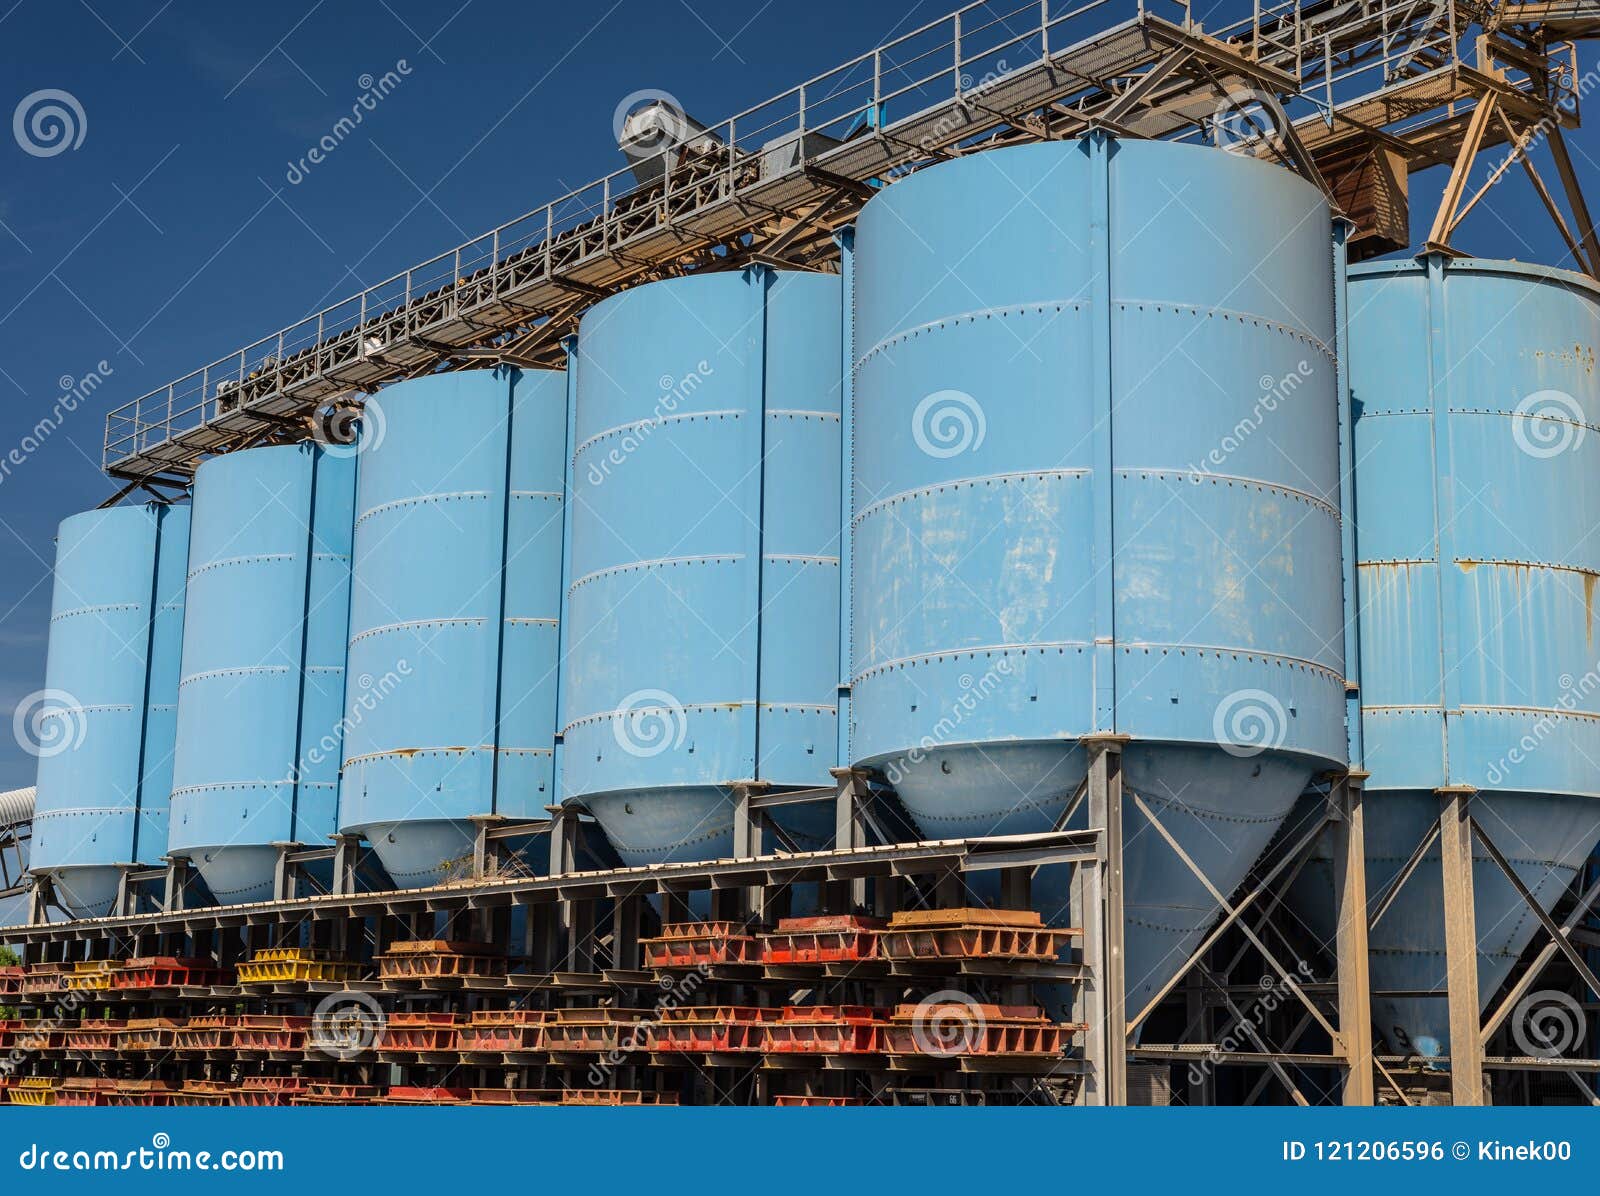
[1331, 777, 1376, 1105]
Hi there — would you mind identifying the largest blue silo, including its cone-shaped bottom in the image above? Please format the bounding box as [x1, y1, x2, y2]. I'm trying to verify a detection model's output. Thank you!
[850, 136, 1346, 1009]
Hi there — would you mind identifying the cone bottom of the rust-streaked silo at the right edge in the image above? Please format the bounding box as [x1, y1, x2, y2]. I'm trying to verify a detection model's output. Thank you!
[1288, 788, 1600, 1062]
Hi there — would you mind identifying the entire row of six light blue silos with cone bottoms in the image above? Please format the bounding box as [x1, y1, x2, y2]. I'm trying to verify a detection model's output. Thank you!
[21, 136, 1600, 1052]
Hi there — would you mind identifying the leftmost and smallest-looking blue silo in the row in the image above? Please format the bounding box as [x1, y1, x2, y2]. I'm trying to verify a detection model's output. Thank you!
[28, 504, 189, 918]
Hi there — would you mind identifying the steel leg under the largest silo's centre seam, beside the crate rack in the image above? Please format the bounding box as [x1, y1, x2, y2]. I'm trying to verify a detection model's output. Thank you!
[1083, 739, 1128, 1105]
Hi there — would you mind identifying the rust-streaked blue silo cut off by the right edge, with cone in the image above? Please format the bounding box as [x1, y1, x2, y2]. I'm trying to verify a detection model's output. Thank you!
[1293, 256, 1600, 1055]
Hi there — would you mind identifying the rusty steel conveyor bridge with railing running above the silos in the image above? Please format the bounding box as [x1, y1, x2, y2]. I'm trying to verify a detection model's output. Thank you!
[102, 0, 1600, 505]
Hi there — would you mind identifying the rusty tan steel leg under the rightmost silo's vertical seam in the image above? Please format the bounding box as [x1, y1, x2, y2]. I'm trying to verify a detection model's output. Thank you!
[1438, 788, 1483, 1105]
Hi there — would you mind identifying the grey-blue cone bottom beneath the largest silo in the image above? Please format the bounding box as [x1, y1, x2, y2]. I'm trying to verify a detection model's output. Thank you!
[898, 742, 1312, 1017]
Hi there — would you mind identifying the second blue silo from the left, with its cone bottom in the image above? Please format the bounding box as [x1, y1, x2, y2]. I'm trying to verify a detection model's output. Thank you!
[171, 445, 355, 905]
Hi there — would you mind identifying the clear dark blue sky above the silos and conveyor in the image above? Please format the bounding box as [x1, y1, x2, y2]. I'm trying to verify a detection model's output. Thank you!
[0, 0, 1600, 788]
